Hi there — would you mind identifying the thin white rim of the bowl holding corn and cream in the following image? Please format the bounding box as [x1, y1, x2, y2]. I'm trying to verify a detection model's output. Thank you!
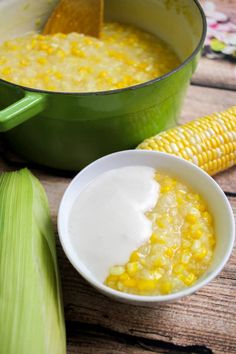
[57, 150, 235, 304]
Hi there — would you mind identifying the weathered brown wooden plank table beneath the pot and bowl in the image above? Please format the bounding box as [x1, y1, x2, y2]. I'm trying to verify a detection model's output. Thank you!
[0, 0, 236, 354]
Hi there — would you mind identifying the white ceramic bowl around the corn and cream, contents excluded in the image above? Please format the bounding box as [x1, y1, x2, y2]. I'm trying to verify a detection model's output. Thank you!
[58, 150, 235, 304]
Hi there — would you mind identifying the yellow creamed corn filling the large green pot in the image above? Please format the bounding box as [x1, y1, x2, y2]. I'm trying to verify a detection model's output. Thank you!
[0, 23, 180, 92]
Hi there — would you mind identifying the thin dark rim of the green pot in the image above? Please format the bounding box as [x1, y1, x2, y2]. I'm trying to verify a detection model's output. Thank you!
[0, 0, 207, 97]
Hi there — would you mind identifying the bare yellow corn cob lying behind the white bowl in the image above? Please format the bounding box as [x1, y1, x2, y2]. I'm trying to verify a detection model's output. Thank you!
[137, 106, 236, 175]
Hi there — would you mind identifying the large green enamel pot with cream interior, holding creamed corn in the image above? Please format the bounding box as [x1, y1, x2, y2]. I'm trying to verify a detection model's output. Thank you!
[0, 0, 206, 170]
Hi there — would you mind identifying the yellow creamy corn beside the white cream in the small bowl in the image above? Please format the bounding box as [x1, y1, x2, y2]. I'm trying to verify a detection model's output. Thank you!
[105, 173, 215, 295]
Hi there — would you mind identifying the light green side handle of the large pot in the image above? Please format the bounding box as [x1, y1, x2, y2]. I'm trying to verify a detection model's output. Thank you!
[0, 92, 46, 132]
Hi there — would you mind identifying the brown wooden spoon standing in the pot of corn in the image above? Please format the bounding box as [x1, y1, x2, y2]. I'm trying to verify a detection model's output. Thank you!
[42, 0, 104, 37]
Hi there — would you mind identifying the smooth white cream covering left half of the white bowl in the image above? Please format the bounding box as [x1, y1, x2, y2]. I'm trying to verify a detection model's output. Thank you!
[68, 166, 159, 282]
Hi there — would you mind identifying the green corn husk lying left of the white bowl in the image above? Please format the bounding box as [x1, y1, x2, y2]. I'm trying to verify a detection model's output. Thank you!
[0, 169, 66, 354]
